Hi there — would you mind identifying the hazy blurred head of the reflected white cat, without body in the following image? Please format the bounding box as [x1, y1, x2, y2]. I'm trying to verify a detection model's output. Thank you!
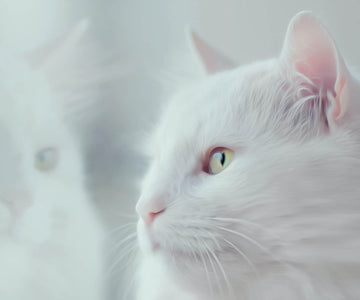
[0, 23, 94, 245]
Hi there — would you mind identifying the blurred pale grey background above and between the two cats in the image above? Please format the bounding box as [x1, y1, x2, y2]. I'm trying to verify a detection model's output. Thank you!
[0, 0, 360, 299]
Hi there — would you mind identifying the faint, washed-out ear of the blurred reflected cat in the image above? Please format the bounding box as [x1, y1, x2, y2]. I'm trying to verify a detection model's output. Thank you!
[25, 19, 108, 121]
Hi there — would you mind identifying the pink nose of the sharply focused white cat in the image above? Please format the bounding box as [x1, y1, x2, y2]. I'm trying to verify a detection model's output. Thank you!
[136, 197, 166, 227]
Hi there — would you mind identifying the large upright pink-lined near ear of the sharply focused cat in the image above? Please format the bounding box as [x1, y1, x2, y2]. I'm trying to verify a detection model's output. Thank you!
[280, 12, 351, 125]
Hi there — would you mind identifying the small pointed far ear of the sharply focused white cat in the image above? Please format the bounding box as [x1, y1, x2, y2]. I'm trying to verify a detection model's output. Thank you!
[187, 28, 236, 74]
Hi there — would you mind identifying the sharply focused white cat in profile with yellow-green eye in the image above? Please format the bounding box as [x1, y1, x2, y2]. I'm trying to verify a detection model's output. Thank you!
[137, 12, 360, 300]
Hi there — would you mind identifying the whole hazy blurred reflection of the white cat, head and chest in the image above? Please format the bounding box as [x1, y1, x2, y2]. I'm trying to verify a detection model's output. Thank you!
[0, 23, 104, 300]
